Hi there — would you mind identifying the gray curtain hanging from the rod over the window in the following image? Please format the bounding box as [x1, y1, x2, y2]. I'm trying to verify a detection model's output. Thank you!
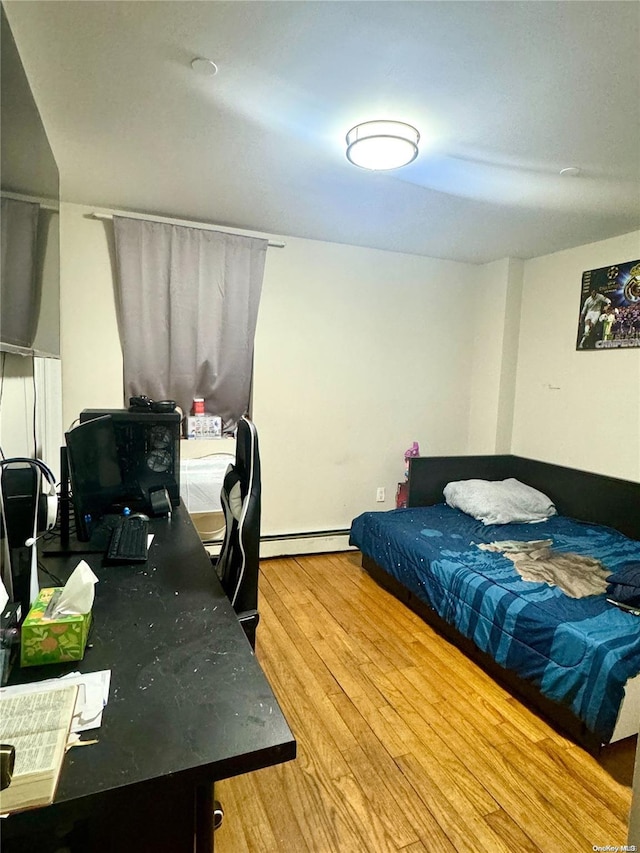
[113, 216, 267, 432]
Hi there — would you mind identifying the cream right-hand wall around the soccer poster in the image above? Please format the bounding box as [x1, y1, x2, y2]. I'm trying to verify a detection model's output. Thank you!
[512, 231, 640, 480]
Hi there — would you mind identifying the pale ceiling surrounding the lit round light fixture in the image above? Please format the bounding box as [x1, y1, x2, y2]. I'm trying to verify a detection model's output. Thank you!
[4, 0, 640, 263]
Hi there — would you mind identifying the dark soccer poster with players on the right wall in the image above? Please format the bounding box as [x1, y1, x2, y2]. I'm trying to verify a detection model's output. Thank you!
[576, 260, 640, 350]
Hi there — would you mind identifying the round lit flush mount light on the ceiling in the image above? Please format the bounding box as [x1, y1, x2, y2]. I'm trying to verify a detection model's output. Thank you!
[347, 121, 420, 171]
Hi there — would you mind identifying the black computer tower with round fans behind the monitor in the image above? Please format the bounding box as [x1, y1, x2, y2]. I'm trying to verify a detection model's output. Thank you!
[80, 409, 180, 506]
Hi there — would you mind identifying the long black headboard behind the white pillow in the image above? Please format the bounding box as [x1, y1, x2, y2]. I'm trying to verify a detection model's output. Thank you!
[408, 455, 640, 539]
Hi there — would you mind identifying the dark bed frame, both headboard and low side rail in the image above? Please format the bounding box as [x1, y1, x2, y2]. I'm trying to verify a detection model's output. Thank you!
[362, 455, 640, 753]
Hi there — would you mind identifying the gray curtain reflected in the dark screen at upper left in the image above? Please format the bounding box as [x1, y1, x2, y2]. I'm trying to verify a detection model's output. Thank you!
[0, 198, 42, 347]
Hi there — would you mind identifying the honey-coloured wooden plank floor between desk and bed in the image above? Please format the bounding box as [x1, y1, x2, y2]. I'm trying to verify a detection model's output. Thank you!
[215, 552, 635, 853]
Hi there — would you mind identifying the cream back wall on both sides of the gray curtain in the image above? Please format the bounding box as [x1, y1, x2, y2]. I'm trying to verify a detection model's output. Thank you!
[61, 204, 482, 534]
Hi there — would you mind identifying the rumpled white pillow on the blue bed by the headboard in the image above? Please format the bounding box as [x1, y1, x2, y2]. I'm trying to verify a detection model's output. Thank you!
[444, 478, 557, 524]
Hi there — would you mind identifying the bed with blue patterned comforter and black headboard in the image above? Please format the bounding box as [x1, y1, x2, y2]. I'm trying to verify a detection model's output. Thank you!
[350, 456, 640, 751]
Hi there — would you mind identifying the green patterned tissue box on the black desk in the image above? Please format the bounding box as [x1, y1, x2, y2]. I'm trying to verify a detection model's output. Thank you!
[20, 587, 91, 666]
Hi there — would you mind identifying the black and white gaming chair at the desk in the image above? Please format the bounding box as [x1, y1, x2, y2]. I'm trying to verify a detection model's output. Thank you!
[215, 417, 261, 649]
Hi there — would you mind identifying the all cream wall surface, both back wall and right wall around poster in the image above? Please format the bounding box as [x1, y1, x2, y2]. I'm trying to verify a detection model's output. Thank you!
[56, 204, 640, 535]
